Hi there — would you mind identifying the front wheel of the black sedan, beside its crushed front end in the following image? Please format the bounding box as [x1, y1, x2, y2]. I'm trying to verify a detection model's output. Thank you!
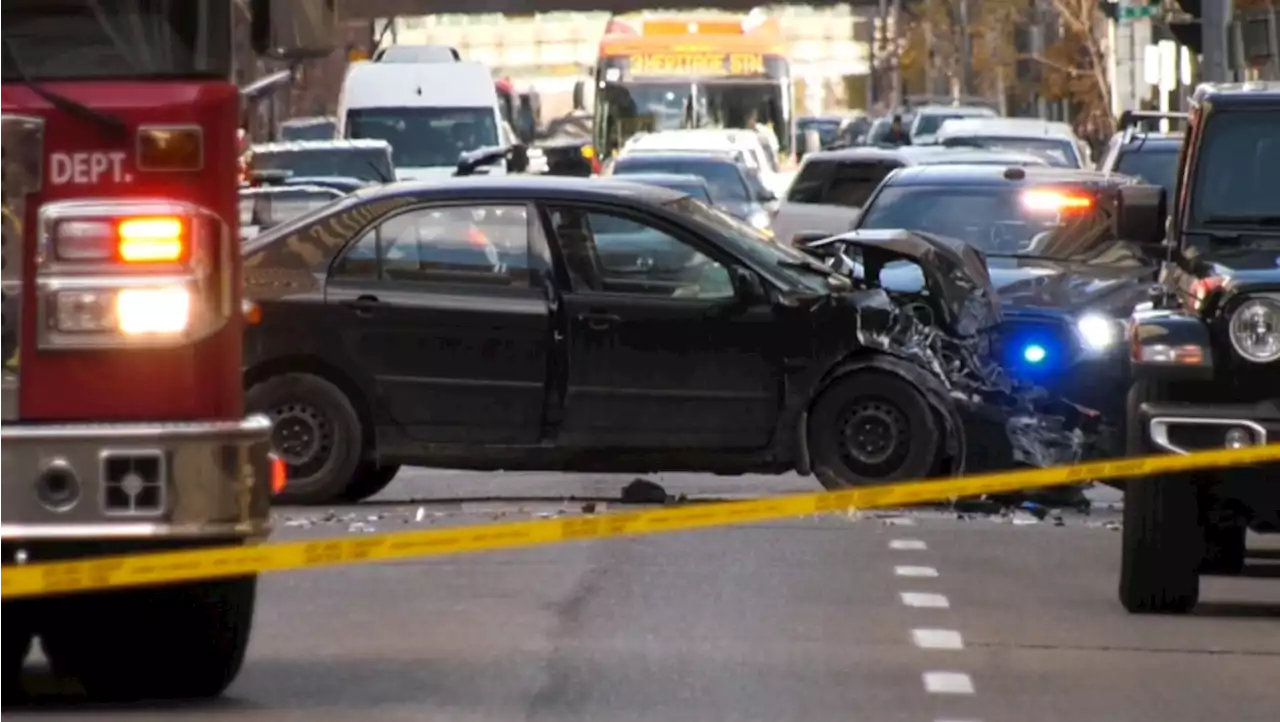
[808, 371, 942, 490]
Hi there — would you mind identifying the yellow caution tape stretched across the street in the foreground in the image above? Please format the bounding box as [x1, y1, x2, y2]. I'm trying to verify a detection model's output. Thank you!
[0, 444, 1280, 599]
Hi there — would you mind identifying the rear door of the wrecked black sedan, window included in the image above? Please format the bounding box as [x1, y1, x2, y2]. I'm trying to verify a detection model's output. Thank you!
[319, 202, 550, 444]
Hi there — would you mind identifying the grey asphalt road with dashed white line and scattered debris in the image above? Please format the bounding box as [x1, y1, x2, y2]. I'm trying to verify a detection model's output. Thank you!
[0, 471, 1280, 722]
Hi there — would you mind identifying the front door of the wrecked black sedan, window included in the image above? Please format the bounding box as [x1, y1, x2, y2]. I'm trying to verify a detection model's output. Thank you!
[547, 204, 781, 449]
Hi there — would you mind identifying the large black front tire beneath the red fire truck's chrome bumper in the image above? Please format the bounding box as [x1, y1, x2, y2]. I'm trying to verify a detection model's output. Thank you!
[41, 577, 257, 702]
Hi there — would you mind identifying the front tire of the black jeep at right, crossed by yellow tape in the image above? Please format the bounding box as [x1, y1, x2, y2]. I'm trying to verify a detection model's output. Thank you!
[1120, 381, 1204, 614]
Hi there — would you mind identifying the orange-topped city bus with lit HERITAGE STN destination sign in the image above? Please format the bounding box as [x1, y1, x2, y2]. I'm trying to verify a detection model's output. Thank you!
[594, 14, 795, 164]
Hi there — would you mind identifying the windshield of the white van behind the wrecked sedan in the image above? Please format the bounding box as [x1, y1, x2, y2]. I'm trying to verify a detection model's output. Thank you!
[347, 108, 498, 168]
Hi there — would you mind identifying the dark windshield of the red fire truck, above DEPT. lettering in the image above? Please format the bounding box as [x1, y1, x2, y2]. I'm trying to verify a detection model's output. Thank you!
[0, 0, 233, 82]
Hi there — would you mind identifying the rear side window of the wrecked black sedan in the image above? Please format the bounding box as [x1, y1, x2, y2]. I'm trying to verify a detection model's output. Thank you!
[334, 205, 529, 284]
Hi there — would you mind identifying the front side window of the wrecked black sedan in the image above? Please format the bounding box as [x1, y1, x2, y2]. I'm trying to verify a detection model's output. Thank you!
[550, 207, 733, 300]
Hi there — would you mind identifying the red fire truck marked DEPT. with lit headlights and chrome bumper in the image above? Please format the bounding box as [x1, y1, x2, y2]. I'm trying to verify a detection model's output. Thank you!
[0, 0, 337, 699]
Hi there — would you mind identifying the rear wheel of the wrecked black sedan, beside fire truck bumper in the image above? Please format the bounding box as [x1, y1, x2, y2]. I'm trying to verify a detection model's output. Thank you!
[244, 374, 365, 504]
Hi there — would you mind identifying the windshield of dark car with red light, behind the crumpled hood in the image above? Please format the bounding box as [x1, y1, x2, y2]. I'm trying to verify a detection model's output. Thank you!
[858, 186, 1114, 259]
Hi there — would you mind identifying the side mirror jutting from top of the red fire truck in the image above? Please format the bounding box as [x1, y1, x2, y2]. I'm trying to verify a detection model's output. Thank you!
[250, 0, 338, 60]
